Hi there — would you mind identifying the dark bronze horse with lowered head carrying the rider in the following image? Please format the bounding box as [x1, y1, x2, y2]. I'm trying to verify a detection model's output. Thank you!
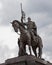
[11, 20, 43, 58]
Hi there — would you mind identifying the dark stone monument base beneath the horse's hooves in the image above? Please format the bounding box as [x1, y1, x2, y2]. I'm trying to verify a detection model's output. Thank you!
[0, 55, 52, 65]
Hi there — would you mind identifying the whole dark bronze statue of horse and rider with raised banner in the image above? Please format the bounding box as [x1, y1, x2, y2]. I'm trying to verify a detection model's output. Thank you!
[11, 4, 43, 58]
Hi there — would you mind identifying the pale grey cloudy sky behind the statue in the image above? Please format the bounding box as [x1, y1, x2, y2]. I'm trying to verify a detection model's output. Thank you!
[0, 0, 52, 63]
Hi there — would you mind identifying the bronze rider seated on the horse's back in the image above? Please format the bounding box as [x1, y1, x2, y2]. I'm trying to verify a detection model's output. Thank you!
[24, 17, 37, 39]
